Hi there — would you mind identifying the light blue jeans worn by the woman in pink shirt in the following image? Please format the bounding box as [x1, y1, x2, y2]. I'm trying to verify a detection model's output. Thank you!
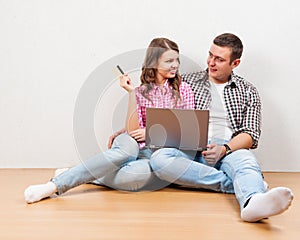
[51, 133, 164, 194]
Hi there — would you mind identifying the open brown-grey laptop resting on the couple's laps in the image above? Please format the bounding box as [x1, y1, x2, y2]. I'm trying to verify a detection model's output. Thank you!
[146, 108, 209, 151]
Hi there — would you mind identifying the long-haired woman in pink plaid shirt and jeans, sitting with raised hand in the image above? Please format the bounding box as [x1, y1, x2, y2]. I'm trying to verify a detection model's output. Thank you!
[24, 38, 194, 203]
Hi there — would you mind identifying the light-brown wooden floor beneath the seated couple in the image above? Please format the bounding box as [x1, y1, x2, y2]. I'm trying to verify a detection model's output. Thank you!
[0, 169, 300, 240]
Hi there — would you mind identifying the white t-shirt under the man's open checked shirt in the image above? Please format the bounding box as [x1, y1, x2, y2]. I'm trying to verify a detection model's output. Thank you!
[208, 82, 233, 142]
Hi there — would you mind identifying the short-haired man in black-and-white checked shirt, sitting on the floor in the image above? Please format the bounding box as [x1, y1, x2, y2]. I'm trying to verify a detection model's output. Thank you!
[150, 33, 293, 222]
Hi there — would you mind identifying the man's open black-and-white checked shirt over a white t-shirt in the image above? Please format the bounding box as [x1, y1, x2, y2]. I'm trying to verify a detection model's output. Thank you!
[182, 71, 261, 148]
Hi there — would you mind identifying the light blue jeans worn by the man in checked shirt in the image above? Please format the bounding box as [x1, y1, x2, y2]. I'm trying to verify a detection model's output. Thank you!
[150, 141, 264, 209]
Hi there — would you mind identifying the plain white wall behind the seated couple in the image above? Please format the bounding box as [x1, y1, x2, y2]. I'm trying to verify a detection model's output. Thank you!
[0, 0, 300, 171]
